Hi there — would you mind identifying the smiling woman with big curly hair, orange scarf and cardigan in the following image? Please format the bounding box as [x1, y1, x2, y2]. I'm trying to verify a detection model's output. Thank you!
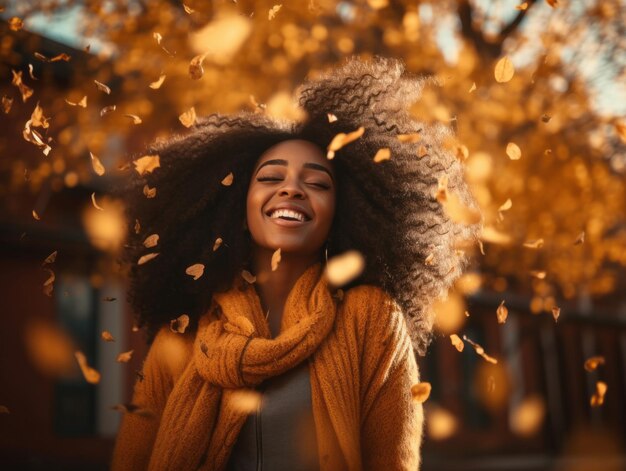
[113, 58, 476, 470]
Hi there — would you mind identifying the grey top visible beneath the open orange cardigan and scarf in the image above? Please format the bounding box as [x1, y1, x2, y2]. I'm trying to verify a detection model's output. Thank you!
[226, 360, 319, 471]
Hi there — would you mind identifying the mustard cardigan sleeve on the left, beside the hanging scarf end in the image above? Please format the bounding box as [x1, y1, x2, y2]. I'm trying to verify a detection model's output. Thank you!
[111, 327, 188, 471]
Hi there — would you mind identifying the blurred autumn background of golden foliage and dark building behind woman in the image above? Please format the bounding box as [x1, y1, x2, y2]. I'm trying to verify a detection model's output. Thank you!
[0, 0, 626, 471]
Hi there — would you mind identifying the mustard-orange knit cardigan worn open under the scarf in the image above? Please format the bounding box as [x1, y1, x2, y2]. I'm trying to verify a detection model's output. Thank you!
[111, 285, 424, 471]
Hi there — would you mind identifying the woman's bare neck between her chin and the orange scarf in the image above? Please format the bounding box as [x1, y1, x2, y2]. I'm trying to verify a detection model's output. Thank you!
[250, 247, 320, 337]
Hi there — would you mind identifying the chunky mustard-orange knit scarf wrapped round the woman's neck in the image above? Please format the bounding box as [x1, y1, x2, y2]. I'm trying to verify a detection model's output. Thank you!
[149, 262, 337, 470]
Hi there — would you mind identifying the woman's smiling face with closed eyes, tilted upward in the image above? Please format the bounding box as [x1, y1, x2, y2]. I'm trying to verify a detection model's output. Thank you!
[246, 139, 335, 254]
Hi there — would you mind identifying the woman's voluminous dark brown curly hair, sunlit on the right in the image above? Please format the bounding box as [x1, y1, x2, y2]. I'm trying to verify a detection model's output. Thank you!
[117, 57, 479, 355]
